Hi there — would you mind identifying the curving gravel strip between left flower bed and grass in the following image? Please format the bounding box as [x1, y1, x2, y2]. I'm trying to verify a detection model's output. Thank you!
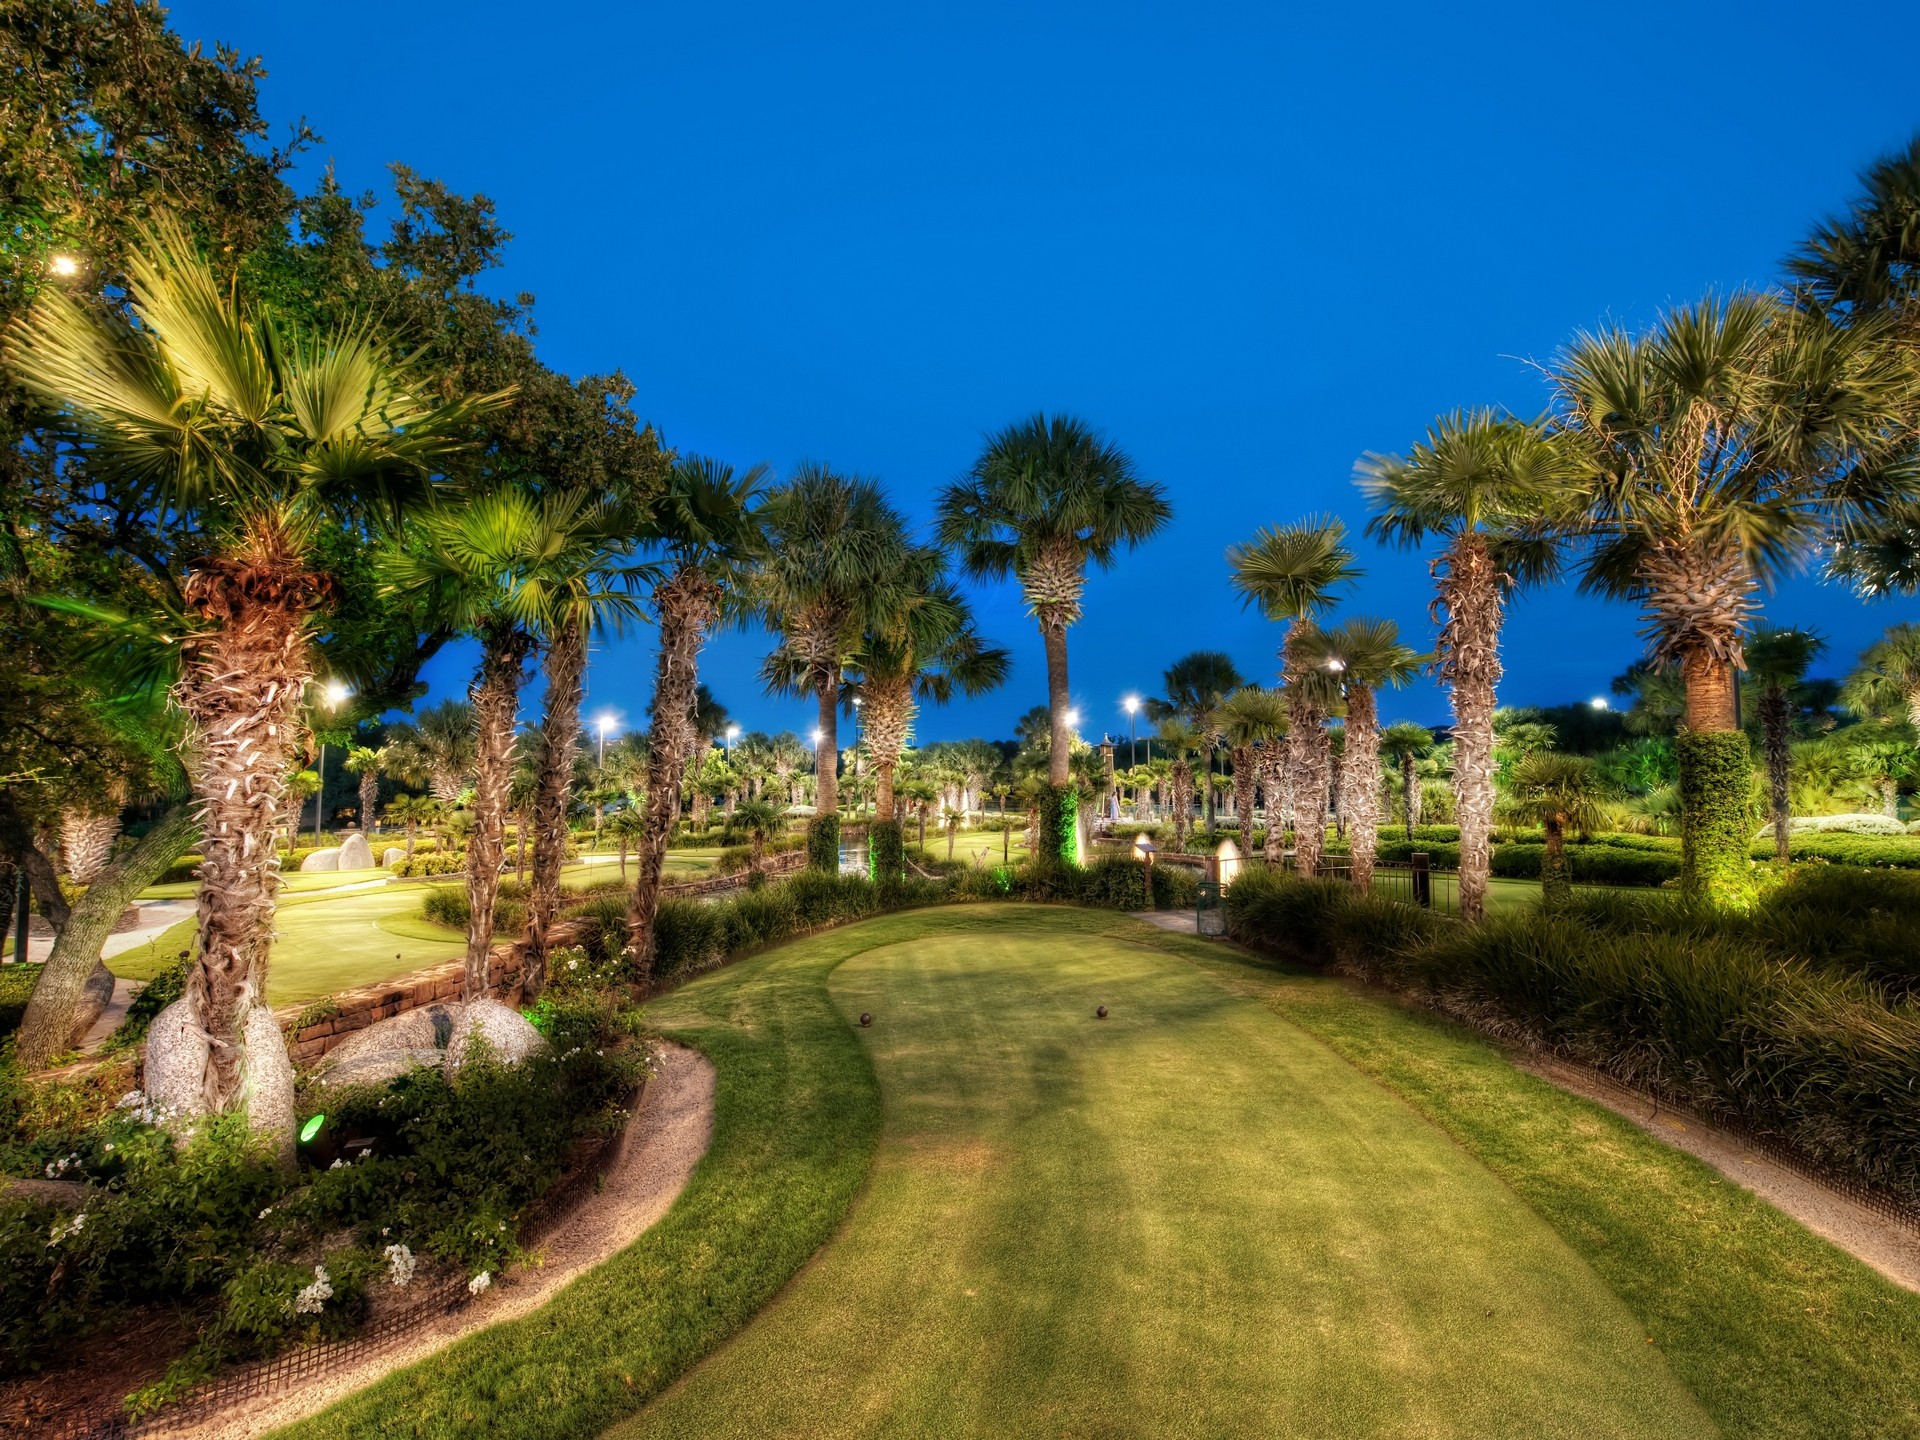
[165, 1043, 714, 1440]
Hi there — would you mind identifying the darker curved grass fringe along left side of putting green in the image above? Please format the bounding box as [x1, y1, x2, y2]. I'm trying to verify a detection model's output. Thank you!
[264, 902, 890, 1440]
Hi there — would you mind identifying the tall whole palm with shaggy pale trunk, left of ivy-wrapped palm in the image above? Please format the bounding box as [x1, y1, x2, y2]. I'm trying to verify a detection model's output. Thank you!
[1356, 411, 1580, 920]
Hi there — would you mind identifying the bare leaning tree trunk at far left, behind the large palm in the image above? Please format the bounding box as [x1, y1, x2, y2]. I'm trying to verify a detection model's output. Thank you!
[15, 804, 200, 1069]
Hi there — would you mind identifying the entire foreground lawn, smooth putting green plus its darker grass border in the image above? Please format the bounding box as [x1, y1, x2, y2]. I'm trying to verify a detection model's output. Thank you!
[259, 904, 1920, 1440]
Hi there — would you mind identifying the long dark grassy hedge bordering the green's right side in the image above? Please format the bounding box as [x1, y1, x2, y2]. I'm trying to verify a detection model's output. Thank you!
[1227, 870, 1920, 1202]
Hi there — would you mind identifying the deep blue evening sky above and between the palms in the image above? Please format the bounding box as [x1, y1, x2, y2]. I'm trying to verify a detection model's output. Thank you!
[173, 0, 1920, 737]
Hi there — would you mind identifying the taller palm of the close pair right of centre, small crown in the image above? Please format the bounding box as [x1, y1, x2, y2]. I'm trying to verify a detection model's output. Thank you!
[1227, 515, 1361, 876]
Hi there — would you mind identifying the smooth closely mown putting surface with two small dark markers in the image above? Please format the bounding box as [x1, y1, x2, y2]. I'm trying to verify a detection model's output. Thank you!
[616, 910, 1716, 1438]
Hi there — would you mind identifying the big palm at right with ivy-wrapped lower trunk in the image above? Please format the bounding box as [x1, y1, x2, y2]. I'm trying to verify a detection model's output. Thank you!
[1553, 296, 1912, 902]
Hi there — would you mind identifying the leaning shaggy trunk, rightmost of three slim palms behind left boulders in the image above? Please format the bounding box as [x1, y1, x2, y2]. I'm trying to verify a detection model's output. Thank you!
[626, 566, 720, 985]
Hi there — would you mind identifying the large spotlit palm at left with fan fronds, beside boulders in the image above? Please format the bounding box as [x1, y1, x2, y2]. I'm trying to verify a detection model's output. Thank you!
[6, 215, 505, 1140]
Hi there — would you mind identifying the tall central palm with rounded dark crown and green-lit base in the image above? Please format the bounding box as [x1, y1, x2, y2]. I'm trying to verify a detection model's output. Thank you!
[939, 413, 1173, 814]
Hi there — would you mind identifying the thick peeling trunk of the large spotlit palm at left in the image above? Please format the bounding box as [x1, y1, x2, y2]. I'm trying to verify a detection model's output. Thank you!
[173, 537, 326, 1112]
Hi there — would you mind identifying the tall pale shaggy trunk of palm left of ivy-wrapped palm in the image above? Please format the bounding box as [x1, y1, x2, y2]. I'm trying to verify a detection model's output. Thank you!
[1440, 532, 1501, 920]
